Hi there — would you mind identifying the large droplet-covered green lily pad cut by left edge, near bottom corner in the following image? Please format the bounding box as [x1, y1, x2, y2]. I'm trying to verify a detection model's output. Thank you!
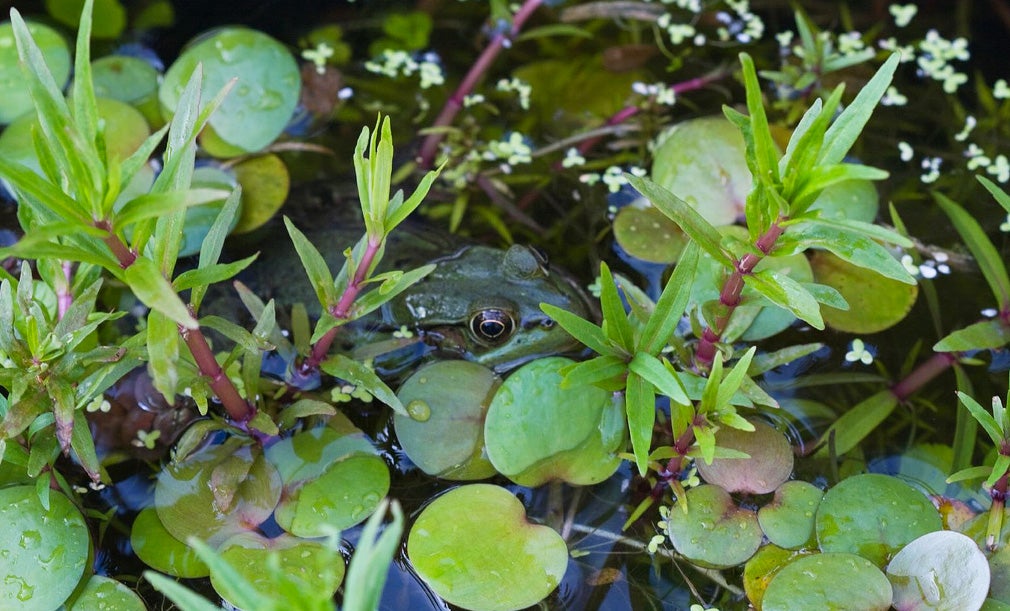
[0, 486, 90, 609]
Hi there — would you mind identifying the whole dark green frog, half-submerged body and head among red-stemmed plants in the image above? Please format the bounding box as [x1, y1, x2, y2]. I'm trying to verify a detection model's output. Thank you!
[229, 178, 596, 374]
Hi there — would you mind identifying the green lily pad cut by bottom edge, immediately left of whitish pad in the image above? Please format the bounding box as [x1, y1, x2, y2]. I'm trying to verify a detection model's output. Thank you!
[762, 552, 891, 611]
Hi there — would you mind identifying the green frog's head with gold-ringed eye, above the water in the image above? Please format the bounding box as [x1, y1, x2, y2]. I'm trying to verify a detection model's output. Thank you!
[389, 245, 594, 371]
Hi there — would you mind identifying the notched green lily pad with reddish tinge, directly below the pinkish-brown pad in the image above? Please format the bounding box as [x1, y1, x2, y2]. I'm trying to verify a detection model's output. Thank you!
[667, 484, 762, 569]
